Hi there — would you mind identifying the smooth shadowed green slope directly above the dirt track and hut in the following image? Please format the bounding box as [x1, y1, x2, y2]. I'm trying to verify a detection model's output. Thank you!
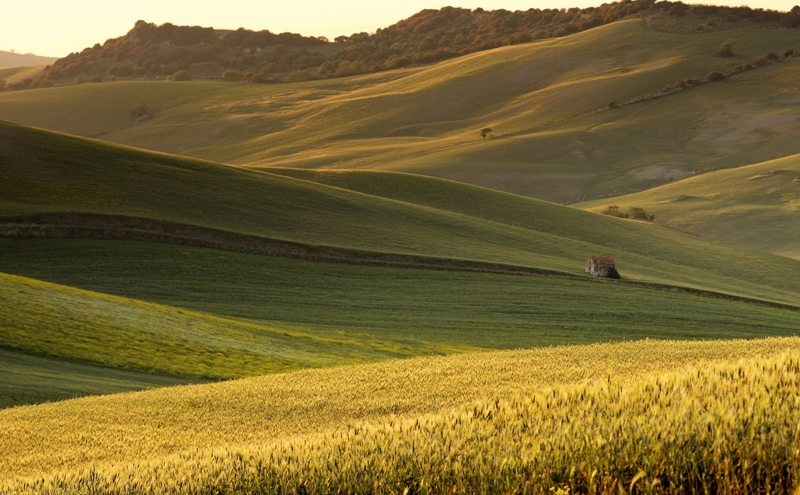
[0, 124, 800, 303]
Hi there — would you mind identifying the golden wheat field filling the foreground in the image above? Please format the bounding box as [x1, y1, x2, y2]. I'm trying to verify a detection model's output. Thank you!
[0, 339, 800, 493]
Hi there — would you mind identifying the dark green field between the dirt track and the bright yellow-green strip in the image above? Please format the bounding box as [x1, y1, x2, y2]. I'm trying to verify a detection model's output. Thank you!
[6, 240, 800, 346]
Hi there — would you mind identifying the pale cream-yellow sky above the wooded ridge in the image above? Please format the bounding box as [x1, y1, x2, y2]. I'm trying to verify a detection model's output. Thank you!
[0, 0, 800, 57]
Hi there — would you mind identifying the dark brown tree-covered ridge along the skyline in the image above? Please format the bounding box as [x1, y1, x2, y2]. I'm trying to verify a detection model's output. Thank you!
[12, 0, 800, 87]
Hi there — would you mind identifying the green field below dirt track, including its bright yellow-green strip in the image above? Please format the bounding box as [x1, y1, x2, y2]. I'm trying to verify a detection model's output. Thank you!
[6, 240, 800, 392]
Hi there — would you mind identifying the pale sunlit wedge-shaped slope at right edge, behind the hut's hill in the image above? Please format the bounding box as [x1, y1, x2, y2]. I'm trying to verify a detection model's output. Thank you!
[578, 155, 800, 259]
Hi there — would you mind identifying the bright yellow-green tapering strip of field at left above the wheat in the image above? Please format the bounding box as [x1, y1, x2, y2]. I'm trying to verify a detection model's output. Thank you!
[0, 272, 390, 379]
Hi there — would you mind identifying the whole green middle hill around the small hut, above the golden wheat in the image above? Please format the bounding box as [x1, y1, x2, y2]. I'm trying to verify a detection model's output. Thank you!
[0, 119, 800, 404]
